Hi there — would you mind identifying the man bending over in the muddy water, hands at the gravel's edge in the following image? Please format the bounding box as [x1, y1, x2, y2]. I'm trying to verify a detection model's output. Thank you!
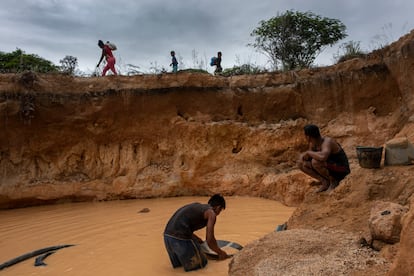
[164, 194, 230, 271]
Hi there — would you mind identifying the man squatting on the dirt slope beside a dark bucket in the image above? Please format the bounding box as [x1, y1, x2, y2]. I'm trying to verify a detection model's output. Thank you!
[297, 125, 351, 192]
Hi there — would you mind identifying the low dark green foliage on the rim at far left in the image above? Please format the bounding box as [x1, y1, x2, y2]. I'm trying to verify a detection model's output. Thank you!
[0, 49, 58, 73]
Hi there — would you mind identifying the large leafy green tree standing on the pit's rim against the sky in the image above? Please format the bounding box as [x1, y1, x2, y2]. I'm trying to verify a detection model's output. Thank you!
[250, 11, 347, 70]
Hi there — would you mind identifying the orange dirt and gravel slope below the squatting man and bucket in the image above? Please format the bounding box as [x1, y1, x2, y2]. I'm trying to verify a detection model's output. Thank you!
[229, 162, 414, 275]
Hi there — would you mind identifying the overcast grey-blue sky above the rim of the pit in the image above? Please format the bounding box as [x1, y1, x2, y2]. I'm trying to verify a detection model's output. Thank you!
[0, 0, 414, 73]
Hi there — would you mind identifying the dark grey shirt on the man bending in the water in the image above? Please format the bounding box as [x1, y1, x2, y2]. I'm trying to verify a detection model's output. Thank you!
[164, 202, 211, 239]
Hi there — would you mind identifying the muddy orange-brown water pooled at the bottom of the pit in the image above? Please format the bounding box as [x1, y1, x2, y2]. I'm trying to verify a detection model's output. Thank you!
[0, 197, 294, 276]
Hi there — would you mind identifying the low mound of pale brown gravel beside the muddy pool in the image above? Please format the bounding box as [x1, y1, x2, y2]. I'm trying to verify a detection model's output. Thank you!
[229, 229, 389, 276]
